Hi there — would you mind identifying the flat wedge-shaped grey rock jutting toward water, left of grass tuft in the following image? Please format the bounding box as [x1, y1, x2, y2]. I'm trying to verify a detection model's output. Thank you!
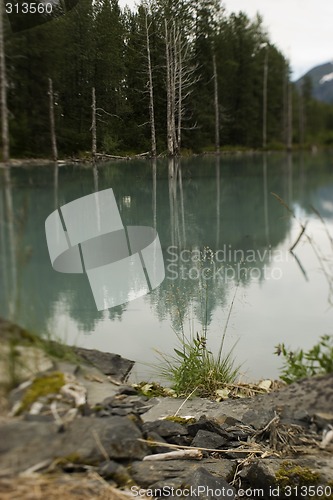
[74, 347, 134, 382]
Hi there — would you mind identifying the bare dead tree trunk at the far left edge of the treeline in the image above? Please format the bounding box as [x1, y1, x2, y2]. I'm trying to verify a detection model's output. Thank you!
[0, 2, 10, 163]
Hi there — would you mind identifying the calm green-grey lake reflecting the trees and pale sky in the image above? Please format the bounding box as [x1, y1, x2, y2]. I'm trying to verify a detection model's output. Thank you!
[0, 153, 333, 380]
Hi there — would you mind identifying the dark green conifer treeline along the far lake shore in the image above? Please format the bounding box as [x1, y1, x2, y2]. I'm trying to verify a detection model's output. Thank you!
[5, 0, 333, 156]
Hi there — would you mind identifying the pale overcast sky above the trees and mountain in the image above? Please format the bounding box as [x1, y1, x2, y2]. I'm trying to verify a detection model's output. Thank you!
[119, 0, 333, 79]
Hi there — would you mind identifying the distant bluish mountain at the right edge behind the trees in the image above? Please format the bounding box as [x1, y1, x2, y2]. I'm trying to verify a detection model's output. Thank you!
[296, 61, 333, 104]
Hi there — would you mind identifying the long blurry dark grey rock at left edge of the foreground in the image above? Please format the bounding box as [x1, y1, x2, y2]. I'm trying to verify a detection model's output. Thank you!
[0, 417, 150, 472]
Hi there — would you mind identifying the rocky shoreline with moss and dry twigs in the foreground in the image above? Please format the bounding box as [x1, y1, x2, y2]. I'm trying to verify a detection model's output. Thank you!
[0, 318, 333, 500]
